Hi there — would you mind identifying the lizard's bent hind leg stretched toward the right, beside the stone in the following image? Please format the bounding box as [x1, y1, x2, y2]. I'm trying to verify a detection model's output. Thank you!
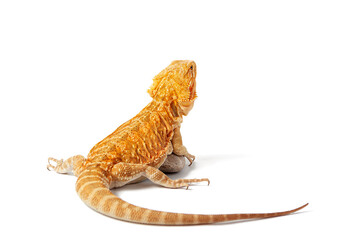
[111, 163, 210, 189]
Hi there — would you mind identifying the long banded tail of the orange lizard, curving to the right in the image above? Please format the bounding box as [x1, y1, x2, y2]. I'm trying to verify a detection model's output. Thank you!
[76, 168, 308, 225]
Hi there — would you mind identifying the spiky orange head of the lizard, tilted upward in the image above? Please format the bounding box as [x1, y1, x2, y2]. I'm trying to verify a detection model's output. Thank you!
[148, 60, 197, 116]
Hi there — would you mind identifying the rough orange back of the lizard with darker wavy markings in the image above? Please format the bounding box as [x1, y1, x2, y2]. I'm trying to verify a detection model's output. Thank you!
[87, 101, 180, 166]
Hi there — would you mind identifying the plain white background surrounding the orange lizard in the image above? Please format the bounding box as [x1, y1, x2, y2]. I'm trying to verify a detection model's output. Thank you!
[0, 0, 360, 239]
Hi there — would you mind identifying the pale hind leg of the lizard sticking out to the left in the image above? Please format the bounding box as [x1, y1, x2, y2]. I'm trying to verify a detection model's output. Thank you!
[47, 155, 85, 173]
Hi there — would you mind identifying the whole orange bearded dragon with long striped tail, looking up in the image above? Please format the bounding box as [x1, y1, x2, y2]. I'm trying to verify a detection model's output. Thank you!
[47, 60, 307, 225]
